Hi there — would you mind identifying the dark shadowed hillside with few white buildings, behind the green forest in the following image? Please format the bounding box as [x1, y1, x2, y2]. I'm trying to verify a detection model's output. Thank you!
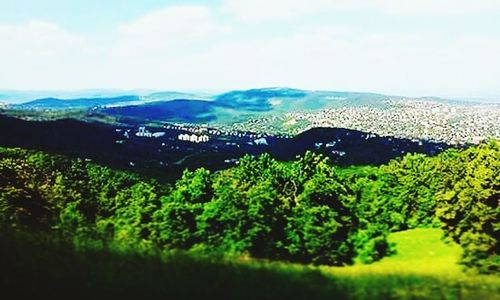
[0, 115, 449, 178]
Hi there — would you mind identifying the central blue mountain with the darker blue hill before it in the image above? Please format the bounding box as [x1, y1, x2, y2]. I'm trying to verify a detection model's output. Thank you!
[96, 88, 394, 123]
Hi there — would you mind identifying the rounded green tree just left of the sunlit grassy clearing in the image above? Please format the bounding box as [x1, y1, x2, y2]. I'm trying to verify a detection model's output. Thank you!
[286, 173, 357, 265]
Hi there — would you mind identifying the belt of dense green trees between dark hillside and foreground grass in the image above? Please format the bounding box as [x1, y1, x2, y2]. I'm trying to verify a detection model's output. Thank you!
[0, 140, 500, 298]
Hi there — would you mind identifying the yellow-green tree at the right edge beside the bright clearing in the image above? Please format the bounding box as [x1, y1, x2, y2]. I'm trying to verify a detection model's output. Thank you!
[436, 141, 500, 273]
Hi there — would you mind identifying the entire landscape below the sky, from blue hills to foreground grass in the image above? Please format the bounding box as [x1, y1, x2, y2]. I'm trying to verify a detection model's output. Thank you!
[0, 88, 500, 299]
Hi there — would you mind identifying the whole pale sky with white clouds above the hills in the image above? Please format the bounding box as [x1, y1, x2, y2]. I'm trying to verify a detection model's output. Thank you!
[0, 0, 500, 98]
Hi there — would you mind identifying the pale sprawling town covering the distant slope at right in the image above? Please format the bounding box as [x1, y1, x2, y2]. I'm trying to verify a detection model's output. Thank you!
[231, 98, 500, 145]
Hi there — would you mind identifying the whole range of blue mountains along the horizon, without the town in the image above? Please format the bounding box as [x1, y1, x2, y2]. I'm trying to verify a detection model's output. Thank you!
[7, 87, 484, 124]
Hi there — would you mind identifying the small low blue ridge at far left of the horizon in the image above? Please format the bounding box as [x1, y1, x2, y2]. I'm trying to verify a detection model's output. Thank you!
[14, 95, 140, 109]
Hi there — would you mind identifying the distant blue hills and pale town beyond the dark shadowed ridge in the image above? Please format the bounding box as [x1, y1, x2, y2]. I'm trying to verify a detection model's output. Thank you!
[0, 88, 500, 145]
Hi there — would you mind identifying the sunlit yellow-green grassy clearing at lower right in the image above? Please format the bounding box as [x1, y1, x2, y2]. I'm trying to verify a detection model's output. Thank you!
[321, 228, 500, 299]
